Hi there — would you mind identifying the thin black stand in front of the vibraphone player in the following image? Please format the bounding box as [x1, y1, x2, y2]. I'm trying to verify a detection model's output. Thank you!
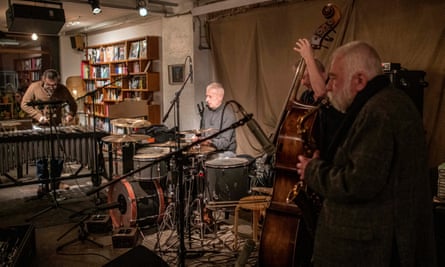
[26, 100, 74, 221]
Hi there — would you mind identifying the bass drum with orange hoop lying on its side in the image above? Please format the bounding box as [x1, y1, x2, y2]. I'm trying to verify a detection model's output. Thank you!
[108, 179, 165, 228]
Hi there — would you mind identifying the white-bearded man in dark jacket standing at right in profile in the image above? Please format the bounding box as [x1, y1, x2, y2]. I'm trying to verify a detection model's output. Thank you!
[297, 41, 436, 266]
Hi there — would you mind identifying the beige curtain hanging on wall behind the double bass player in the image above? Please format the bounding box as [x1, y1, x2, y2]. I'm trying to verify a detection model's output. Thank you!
[209, 0, 445, 166]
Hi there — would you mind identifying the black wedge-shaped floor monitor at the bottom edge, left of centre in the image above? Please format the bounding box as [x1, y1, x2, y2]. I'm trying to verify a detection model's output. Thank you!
[103, 245, 169, 267]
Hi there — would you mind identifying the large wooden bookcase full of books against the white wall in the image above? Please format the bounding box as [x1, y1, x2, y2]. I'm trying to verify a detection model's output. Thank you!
[81, 36, 161, 130]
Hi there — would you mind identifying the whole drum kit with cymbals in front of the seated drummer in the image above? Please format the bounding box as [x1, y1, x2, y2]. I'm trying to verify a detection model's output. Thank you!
[102, 119, 252, 228]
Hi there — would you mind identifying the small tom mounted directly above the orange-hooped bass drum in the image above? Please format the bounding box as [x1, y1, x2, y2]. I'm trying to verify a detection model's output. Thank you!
[133, 147, 169, 181]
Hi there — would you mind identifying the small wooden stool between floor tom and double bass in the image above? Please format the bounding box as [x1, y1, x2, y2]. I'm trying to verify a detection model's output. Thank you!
[233, 195, 271, 249]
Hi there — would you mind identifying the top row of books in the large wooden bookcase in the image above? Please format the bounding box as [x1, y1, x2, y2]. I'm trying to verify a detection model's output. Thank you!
[87, 39, 147, 63]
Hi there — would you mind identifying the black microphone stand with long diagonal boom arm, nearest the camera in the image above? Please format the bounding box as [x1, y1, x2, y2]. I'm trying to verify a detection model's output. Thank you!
[86, 116, 252, 267]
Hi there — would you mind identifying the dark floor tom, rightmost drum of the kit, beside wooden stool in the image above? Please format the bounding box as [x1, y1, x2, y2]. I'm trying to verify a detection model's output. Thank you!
[205, 157, 250, 201]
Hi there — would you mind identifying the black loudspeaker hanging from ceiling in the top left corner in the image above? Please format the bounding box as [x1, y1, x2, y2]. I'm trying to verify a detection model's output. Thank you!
[6, 4, 65, 34]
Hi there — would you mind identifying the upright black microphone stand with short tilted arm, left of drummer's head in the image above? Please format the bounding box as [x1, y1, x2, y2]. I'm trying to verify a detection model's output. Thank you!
[162, 57, 193, 266]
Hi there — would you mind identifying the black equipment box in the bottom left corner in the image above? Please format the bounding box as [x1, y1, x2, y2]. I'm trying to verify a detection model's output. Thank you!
[0, 224, 36, 267]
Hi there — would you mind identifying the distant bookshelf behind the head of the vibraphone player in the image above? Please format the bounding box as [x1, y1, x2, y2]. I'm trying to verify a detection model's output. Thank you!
[14, 54, 50, 87]
